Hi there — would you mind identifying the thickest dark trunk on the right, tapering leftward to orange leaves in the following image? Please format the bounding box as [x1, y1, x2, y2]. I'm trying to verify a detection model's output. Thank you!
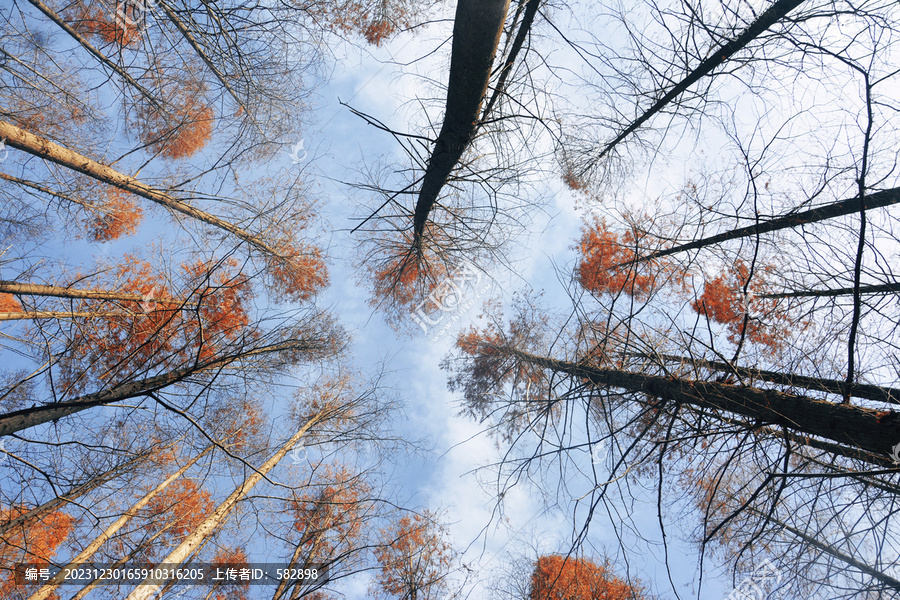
[502, 346, 900, 455]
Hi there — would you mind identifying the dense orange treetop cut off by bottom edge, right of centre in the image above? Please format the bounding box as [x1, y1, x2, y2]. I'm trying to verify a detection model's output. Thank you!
[530, 555, 646, 600]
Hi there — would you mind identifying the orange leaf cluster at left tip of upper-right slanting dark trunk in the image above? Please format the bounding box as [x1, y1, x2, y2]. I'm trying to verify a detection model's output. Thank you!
[576, 220, 663, 299]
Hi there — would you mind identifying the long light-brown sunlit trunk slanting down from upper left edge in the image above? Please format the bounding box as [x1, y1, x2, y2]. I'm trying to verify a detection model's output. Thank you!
[0, 120, 285, 260]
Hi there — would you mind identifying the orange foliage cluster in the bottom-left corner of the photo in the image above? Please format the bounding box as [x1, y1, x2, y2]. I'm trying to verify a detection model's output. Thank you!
[0, 506, 75, 599]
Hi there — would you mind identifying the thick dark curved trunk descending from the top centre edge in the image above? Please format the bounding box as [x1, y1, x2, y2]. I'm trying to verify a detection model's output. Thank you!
[413, 0, 509, 249]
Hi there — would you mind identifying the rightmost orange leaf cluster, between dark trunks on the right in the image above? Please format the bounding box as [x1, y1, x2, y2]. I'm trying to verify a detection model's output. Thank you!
[691, 259, 802, 350]
